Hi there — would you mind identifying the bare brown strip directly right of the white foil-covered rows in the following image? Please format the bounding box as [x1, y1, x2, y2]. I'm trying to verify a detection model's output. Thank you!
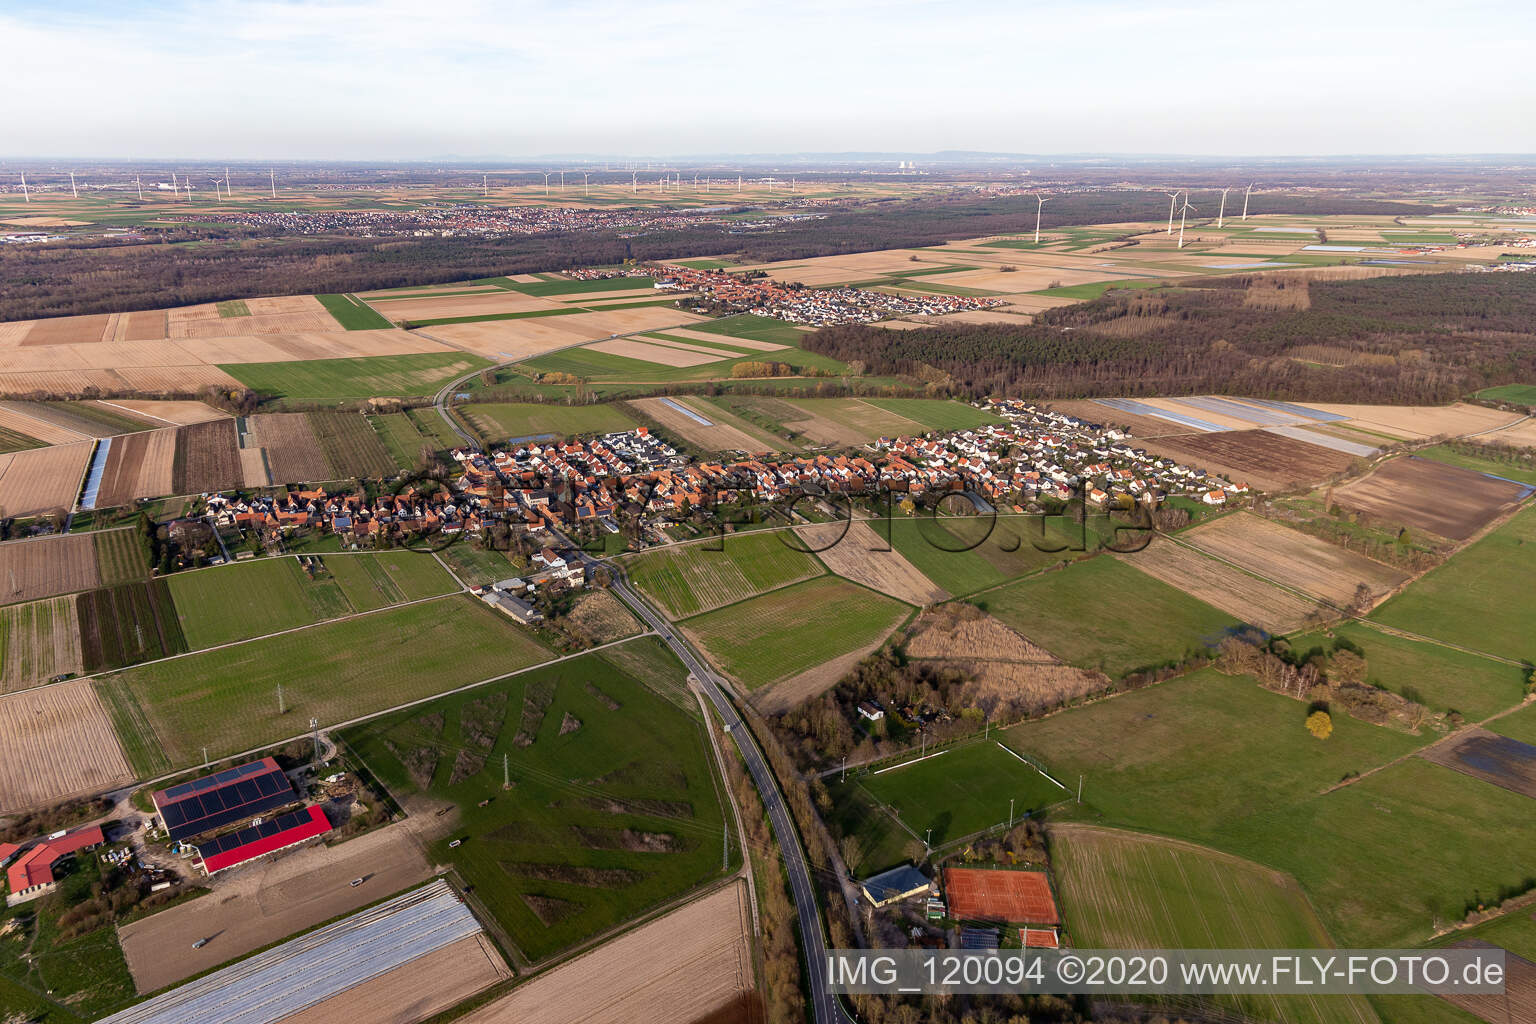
[280, 932, 511, 1024]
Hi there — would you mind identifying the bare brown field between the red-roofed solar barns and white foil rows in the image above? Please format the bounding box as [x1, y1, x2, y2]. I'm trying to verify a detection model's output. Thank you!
[118, 824, 432, 994]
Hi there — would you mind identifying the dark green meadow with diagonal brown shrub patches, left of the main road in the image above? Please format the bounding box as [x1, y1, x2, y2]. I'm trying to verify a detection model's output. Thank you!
[344, 640, 740, 960]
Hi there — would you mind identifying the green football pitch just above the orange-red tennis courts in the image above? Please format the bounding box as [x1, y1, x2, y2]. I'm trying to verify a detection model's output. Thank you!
[829, 740, 1068, 870]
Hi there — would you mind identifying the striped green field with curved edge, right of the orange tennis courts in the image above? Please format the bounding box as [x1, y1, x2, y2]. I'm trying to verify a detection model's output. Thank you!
[1051, 824, 1376, 1024]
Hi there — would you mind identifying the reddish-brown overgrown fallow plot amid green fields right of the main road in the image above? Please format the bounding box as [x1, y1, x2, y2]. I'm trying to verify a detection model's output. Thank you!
[903, 605, 1109, 712]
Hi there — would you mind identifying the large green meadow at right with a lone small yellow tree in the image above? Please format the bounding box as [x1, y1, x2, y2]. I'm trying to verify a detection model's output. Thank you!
[1003, 669, 1536, 947]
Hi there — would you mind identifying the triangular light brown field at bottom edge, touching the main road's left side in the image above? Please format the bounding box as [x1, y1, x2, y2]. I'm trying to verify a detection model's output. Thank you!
[464, 883, 760, 1024]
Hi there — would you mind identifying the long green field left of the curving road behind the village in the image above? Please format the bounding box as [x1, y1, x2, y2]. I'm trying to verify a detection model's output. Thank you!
[220, 352, 490, 402]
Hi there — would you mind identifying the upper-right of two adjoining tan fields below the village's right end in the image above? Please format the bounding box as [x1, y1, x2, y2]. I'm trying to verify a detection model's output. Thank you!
[1180, 513, 1405, 608]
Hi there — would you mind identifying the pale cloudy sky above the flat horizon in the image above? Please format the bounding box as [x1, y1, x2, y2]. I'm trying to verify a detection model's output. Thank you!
[0, 0, 1536, 160]
